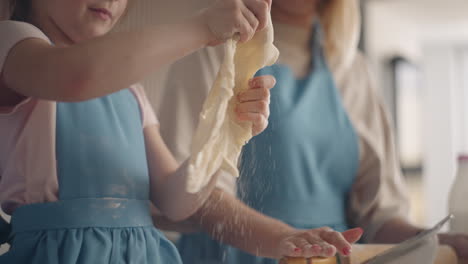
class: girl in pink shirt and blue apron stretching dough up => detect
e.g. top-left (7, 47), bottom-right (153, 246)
top-left (0, 0), bottom-right (269, 264)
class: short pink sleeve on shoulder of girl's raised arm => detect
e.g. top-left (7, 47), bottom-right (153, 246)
top-left (0, 20), bottom-right (50, 72)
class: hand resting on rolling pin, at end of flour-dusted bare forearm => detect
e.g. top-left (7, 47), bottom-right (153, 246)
top-left (279, 227), bottom-right (363, 258)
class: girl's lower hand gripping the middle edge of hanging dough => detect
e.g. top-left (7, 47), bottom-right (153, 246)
top-left (235, 75), bottom-right (276, 136)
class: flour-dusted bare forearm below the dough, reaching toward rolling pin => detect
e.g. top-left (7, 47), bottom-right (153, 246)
top-left (190, 188), bottom-right (296, 258)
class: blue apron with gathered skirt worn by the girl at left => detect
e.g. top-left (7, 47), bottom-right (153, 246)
top-left (0, 89), bottom-right (181, 264)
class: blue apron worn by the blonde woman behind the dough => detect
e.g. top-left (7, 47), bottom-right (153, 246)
top-left (179, 24), bottom-right (359, 264)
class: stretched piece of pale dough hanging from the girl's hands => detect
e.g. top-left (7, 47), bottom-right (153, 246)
top-left (186, 14), bottom-right (279, 193)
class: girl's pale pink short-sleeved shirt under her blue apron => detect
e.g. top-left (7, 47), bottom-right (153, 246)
top-left (0, 21), bottom-right (158, 215)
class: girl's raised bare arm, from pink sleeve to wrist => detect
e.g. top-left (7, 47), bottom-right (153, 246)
top-left (4, 16), bottom-right (210, 101)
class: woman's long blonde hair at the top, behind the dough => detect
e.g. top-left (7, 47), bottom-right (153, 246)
top-left (319, 0), bottom-right (361, 74)
